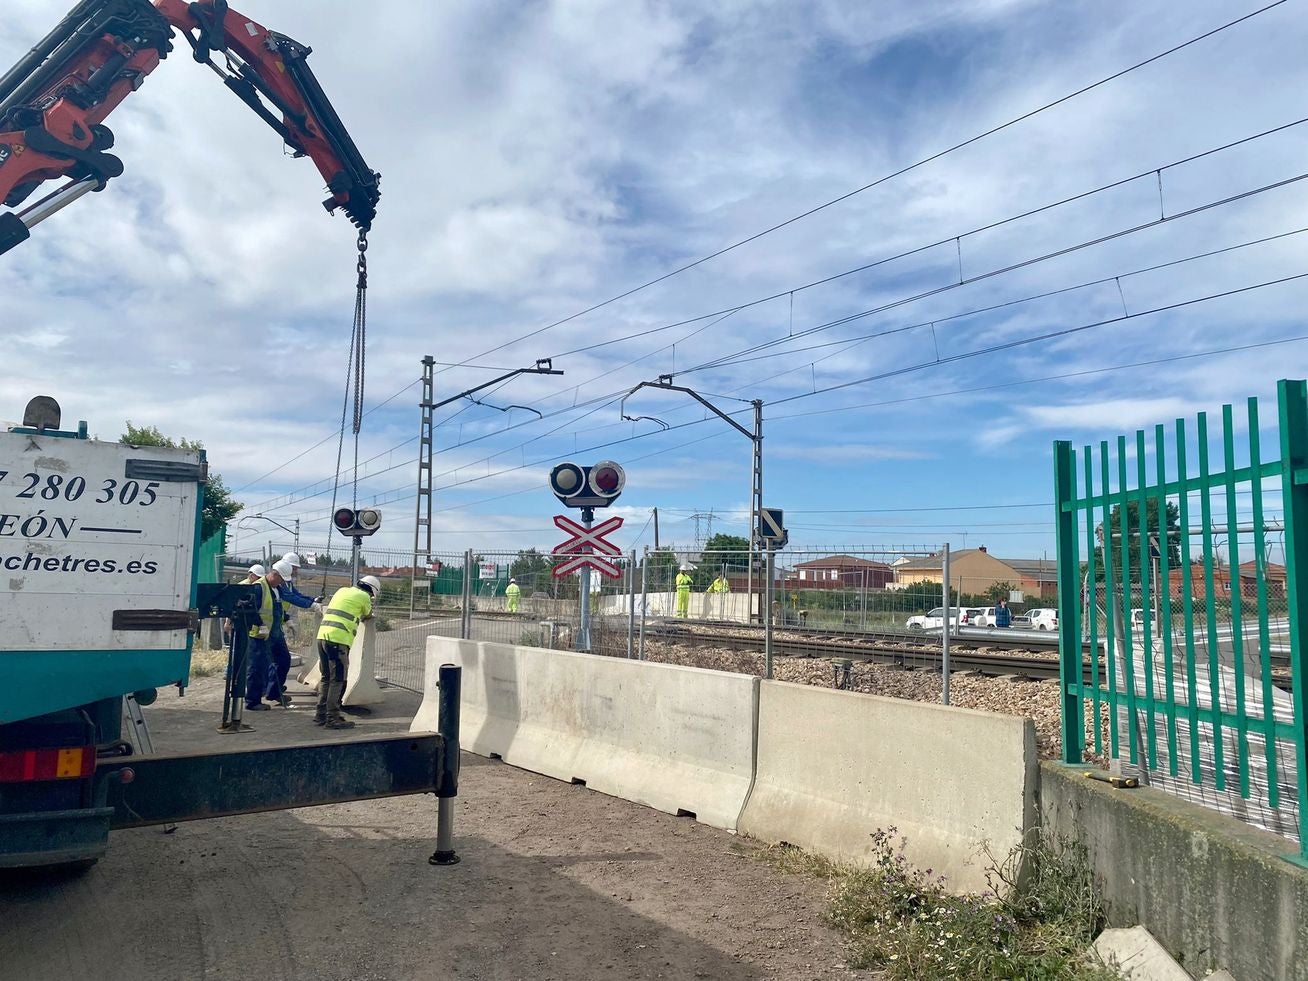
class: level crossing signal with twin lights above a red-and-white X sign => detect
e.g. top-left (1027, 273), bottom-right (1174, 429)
top-left (549, 460), bottom-right (627, 651)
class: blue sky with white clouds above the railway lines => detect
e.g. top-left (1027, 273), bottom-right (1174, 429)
top-left (0, 0), bottom-right (1308, 557)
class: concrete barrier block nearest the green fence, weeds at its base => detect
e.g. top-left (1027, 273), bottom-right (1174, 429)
top-left (739, 681), bottom-right (1039, 892)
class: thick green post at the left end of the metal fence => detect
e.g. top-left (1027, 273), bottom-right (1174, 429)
top-left (1054, 439), bottom-right (1097, 765)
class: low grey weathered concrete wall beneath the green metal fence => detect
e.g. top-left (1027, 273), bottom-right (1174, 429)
top-left (1040, 763), bottom-right (1308, 981)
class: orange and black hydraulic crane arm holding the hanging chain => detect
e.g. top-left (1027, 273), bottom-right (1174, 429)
top-left (0, 0), bottom-right (381, 252)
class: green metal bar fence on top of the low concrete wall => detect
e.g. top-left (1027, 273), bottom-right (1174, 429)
top-left (1054, 381), bottom-right (1308, 865)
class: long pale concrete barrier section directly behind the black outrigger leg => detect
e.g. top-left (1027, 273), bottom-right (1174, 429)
top-left (412, 637), bottom-right (759, 831)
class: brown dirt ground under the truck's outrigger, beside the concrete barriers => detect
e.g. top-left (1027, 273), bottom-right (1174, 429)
top-left (0, 678), bottom-right (869, 981)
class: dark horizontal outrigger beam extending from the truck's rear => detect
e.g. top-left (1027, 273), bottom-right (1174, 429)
top-left (97, 732), bottom-right (445, 829)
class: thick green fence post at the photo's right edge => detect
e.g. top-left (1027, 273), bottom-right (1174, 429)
top-left (1277, 381), bottom-right (1308, 866)
